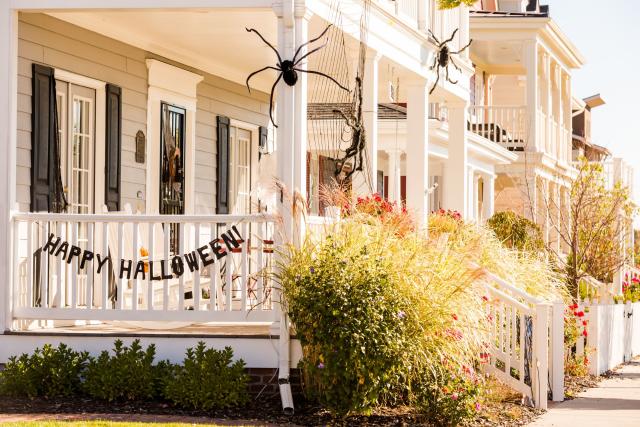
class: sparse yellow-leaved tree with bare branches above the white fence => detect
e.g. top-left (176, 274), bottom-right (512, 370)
top-left (543, 158), bottom-right (635, 295)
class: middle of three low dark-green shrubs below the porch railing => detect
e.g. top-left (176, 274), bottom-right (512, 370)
top-left (84, 340), bottom-right (158, 402)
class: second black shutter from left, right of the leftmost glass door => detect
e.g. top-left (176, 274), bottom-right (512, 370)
top-left (104, 84), bottom-right (122, 211)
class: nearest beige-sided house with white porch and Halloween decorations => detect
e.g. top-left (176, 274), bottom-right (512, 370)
top-left (0, 0), bottom-right (517, 402)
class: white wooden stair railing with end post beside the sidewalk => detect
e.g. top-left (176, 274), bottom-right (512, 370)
top-left (485, 272), bottom-right (564, 409)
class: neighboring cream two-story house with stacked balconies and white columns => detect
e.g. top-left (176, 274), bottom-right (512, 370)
top-left (470, 1), bottom-right (584, 254)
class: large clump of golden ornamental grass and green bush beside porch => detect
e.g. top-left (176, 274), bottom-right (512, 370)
top-left (277, 190), bottom-right (565, 425)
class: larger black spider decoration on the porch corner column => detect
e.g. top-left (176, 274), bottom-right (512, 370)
top-left (246, 24), bottom-right (349, 128)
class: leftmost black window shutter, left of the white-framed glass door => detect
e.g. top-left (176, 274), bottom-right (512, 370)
top-left (31, 64), bottom-right (56, 212)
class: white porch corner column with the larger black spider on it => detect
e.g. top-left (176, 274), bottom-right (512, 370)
top-left (274, 2), bottom-right (296, 242)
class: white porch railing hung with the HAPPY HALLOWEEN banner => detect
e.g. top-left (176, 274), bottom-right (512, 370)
top-left (12, 213), bottom-right (275, 323)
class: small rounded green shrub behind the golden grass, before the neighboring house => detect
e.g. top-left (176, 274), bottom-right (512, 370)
top-left (487, 211), bottom-right (544, 252)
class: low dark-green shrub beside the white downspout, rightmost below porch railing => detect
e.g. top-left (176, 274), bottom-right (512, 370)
top-left (164, 341), bottom-right (249, 410)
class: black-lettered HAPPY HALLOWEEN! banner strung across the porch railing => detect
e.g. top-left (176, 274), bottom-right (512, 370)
top-left (36, 225), bottom-right (244, 281)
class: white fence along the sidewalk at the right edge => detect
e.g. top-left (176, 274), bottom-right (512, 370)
top-left (577, 301), bottom-right (640, 375)
